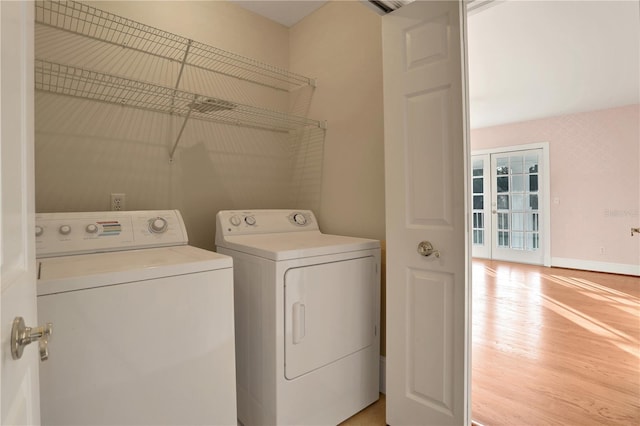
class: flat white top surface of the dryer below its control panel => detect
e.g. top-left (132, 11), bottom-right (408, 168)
top-left (218, 231), bottom-right (380, 261)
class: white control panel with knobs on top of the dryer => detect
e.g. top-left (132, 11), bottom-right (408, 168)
top-left (216, 210), bottom-right (319, 235)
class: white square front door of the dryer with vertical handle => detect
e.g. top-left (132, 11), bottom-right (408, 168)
top-left (285, 257), bottom-right (377, 379)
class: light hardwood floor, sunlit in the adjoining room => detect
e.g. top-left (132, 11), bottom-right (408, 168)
top-left (344, 259), bottom-right (640, 426)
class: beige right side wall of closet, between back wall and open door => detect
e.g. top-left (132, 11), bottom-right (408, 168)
top-left (289, 1), bottom-right (385, 239)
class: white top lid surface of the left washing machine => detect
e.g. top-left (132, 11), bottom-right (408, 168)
top-left (37, 246), bottom-right (233, 296)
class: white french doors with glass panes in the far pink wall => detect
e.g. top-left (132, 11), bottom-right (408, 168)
top-left (471, 147), bottom-right (549, 265)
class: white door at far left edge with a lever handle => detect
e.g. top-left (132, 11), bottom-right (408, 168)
top-left (0, 1), bottom-right (40, 425)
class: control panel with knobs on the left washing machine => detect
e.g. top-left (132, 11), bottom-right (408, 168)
top-left (35, 210), bottom-right (188, 258)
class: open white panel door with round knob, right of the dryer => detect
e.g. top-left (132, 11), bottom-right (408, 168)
top-left (382, 1), bottom-right (470, 426)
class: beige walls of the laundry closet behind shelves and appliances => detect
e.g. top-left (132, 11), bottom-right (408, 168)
top-left (36, 1), bottom-right (384, 249)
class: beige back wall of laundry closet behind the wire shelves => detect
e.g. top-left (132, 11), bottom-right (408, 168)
top-left (35, 1), bottom-right (323, 249)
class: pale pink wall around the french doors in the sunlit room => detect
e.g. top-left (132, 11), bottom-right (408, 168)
top-left (471, 104), bottom-right (640, 273)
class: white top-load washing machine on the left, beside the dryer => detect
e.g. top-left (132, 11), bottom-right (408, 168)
top-left (36, 210), bottom-right (237, 425)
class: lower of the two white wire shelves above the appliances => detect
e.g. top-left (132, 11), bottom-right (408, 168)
top-left (35, 59), bottom-right (323, 134)
